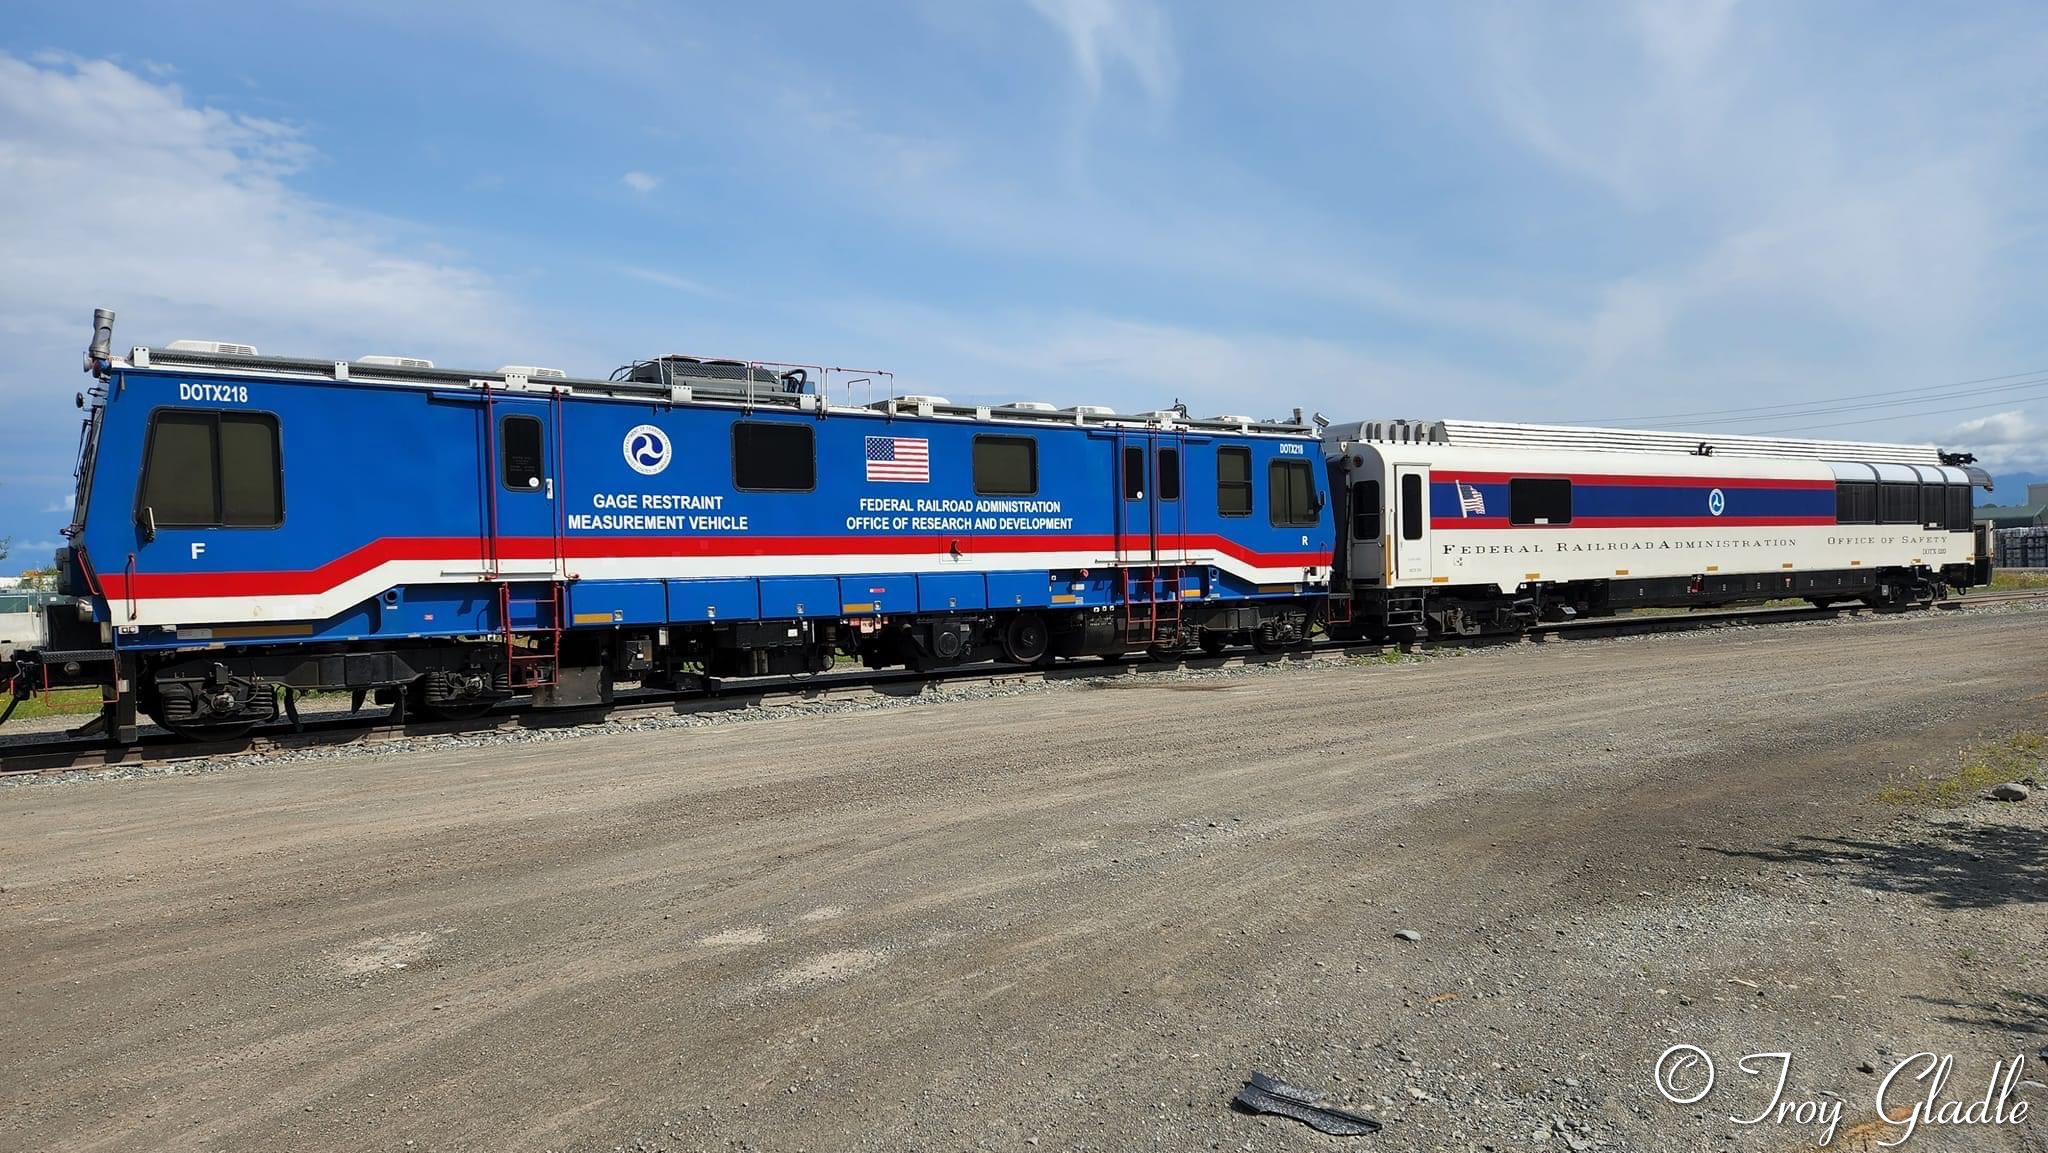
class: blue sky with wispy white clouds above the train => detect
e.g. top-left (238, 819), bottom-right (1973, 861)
top-left (0, 0), bottom-right (2048, 559)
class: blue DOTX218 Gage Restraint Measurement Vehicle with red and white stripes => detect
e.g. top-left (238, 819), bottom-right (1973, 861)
top-left (36, 311), bottom-right (1335, 733)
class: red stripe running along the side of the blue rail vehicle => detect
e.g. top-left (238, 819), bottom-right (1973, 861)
top-left (102, 532), bottom-right (1331, 600)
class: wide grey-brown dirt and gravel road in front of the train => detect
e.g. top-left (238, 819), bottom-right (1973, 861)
top-left (0, 610), bottom-right (2048, 1151)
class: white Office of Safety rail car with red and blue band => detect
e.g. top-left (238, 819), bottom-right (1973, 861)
top-left (1323, 420), bottom-right (1989, 635)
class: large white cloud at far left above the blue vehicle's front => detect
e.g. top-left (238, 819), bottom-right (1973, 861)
top-left (0, 53), bottom-right (522, 360)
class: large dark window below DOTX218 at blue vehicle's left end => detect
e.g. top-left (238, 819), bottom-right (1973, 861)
top-left (137, 412), bottom-right (285, 528)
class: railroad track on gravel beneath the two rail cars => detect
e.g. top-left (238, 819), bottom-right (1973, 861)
top-left (0, 590), bottom-right (2048, 776)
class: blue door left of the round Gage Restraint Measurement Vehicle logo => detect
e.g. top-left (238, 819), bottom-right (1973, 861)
top-left (485, 397), bottom-right (561, 580)
